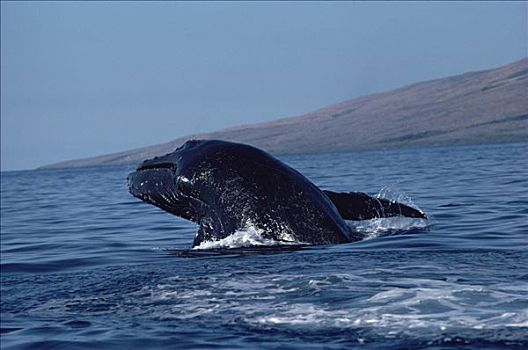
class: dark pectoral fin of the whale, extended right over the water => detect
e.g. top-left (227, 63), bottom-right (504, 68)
top-left (323, 191), bottom-right (427, 220)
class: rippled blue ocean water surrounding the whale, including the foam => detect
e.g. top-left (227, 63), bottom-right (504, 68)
top-left (1, 143), bottom-right (528, 349)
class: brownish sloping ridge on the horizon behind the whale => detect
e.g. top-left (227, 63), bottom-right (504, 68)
top-left (42, 58), bottom-right (528, 168)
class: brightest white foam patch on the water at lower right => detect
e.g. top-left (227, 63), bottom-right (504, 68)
top-left (251, 281), bottom-right (528, 335)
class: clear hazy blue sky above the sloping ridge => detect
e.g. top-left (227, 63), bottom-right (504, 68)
top-left (1, 1), bottom-right (528, 171)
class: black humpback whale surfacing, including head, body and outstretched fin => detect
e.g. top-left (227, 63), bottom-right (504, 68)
top-left (128, 140), bottom-right (426, 247)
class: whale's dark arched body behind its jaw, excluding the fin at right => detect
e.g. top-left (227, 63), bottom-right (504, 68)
top-left (179, 141), bottom-right (350, 245)
